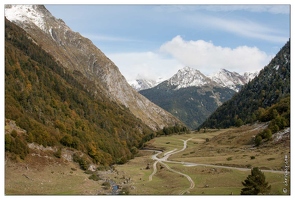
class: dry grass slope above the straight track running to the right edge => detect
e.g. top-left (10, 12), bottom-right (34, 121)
top-left (170, 125), bottom-right (290, 170)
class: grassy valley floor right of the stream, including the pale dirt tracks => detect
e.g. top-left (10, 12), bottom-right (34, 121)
top-left (105, 124), bottom-right (290, 195)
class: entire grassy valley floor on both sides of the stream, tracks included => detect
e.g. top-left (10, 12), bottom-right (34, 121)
top-left (5, 124), bottom-right (290, 195)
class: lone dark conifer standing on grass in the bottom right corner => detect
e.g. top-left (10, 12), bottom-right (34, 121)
top-left (241, 167), bottom-right (271, 195)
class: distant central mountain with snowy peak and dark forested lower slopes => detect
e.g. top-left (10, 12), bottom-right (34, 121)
top-left (139, 67), bottom-right (236, 129)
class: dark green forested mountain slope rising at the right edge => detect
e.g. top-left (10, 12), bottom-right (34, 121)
top-left (200, 41), bottom-right (290, 128)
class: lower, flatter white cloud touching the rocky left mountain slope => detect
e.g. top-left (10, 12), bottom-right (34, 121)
top-left (107, 52), bottom-right (184, 81)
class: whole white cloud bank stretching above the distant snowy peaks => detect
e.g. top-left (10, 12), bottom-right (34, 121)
top-left (107, 36), bottom-right (272, 81)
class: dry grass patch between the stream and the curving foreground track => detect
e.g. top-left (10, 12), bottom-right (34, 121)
top-left (111, 152), bottom-right (189, 195)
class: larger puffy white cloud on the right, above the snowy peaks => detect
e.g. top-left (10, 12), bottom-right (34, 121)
top-left (160, 36), bottom-right (271, 75)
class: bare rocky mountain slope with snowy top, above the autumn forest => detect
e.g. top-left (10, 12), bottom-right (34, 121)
top-left (5, 5), bottom-right (181, 130)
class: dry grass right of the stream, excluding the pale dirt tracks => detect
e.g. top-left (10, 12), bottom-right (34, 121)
top-left (113, 122), bottom-right (290, 195)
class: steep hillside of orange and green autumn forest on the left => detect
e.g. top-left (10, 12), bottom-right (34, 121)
top-left (5, 19), bottom-right (152, 165)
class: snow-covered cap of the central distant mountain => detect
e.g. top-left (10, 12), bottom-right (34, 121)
top-left (168, 67), bottom-right (212, 89)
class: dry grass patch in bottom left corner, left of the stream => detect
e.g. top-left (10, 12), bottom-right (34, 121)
top-left (5, 152), bottom-right (108, 195)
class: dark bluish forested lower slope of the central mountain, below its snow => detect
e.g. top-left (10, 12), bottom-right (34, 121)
top-left (140, 81), bottom-right (235, 129)
